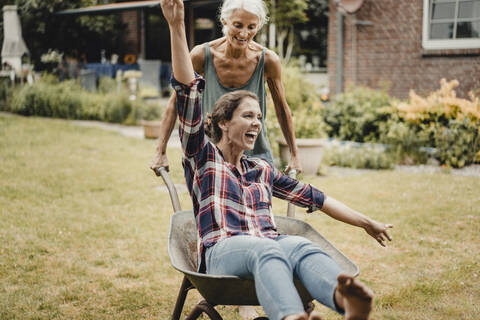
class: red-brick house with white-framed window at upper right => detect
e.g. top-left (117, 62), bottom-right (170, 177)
top-left (327, 0), bottom-right (480, 98)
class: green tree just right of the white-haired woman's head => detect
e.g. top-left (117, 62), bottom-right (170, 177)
top-left (267, 0), bottom-right (308, 62)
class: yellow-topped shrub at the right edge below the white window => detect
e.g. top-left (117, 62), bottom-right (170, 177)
top-left (395, 79), bottom-right (480, 167)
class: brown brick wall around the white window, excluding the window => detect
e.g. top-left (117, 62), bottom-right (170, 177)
top-left (327, 0), bottom-right (480, 98)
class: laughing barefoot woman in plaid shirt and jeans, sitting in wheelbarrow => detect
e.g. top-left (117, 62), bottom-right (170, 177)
top-left (161, 0), bottom-right (392, 320)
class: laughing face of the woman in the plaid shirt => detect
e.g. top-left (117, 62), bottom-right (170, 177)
top-left (221, 97), bottom-right (262, 151)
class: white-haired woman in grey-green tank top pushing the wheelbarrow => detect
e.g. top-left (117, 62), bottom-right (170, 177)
top-left (150, 0), bottom-right (301, 172)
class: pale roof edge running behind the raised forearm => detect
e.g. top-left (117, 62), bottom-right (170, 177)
top-left (56, 0), bottom-right (220, 15)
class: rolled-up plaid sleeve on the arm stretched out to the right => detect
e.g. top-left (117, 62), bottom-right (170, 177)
top-left (273, 168), bottom-right (325, 212)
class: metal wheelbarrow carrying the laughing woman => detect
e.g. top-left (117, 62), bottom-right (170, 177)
top-left (158, 168), bottom-right (359, 320)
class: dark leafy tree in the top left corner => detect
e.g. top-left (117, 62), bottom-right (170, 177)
top-left (0, 0), bottom-right (124, 65)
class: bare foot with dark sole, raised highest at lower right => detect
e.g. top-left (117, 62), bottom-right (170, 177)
top-left (337, 274), bottom-right (373, 320)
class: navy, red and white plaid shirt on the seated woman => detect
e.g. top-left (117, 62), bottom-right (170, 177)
top-left (172, 75), bottom-right (324, 272)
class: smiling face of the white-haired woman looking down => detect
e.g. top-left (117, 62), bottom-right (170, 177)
top-left (222, 9), bottom-right (259, 48)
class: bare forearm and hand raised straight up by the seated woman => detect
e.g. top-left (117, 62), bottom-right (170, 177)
top-left (160, 0), bottom-right (195, 84)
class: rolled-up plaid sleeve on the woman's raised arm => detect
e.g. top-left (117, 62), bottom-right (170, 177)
top-left (171, 74), bottom-right (206, 157)
